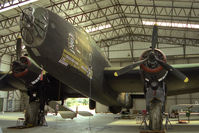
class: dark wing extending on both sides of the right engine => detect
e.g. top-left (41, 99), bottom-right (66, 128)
top-left (104, 64), bottom-right (199, 95)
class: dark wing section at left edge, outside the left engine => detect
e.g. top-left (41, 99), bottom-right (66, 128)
top-left (0, 72), bottom-right (27, 91)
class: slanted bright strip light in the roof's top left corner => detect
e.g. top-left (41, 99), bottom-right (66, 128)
top-left (0, 0), bottom-right (38, 13)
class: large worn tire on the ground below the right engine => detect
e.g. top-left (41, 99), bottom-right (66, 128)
top-left (149, 99), bottom-right (162, 130)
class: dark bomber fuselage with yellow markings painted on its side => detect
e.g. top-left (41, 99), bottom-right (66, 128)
top-left (22, 8), bottom-right (120, 106)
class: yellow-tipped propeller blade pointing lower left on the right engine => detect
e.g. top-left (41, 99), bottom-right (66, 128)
top-left (114, 58), bottom-right (148, 77)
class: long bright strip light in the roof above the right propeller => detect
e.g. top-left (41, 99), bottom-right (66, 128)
top-left (142, 21), bottom-right (199, 29)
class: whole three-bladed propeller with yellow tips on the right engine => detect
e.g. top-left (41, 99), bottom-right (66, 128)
top-left (114, 25), bottom-right (189, 83)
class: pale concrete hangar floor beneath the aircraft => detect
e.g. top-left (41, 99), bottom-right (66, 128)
top-left (0, 113), bottom-right (199, 133)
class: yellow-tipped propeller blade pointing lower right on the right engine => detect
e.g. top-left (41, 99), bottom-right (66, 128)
top-left (156, 58), bottom-right (189, 83)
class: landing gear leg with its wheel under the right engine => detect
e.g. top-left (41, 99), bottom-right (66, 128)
top-left (145, 81), bottom-right (167, 130)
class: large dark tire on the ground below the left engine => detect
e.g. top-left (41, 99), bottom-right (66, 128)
top-left (24, 102), bottom-right (40, 126)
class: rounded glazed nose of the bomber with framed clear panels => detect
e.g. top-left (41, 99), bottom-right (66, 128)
top-left (20, 7), bottom-right (48, 47)
